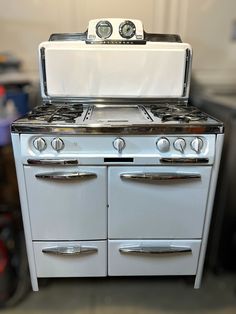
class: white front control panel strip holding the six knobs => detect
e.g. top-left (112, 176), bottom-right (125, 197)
top-left (21, 134), bottom-right (216, 164)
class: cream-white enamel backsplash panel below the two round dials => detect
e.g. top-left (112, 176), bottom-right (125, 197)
top-left (40, 42), bottom-right (191, 97)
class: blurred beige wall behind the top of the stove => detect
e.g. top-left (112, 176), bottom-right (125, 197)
top-left (0, 0), bottom-right (236, 81)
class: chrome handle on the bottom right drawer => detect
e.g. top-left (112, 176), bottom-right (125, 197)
top-left (119, 245), bottom-right (192, 255)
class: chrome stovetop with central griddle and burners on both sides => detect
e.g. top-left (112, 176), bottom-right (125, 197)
top-left (12, 103), bottom-right (222, 133)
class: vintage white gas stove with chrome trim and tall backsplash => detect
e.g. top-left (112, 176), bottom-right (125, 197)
top-left (12, 19), bottom-right (223, 291)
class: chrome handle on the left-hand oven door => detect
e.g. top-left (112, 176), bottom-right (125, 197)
top-left (35, 172), bottom-right (97, 180)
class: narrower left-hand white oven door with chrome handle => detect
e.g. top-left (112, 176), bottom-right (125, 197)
top-left (24, 166), bottom-right (107, 241)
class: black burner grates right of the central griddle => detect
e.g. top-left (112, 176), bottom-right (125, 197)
top-left (151, 104), bottom-right (208, 123)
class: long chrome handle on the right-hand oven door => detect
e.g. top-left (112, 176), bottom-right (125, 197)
top-left (120, 172), bottom-right (201, 181)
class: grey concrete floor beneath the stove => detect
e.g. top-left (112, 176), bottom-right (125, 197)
top-left (1, 274), bottom-right (236, 314)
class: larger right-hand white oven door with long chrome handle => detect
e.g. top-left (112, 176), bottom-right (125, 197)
top-left (108, 166), bottom-right (211, 239)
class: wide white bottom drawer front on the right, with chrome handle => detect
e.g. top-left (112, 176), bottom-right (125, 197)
top-left (108, 240), bottom-right (201, 276)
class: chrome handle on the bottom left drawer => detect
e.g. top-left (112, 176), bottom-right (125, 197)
top-left (42, 246), bottom-right (98, 255)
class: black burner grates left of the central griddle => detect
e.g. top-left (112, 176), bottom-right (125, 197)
top-left (28, 104), bottom-right (83, 123)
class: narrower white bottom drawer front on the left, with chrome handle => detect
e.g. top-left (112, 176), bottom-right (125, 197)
top-left (33, 241), bottom-right (107, 277)
